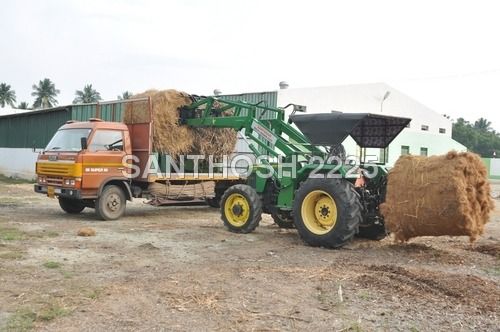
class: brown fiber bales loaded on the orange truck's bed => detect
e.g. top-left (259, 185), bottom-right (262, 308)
top-left (123, 90), bottom-right (237, 157)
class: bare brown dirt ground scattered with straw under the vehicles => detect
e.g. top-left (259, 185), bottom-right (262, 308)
top-left (0, 182), bottom-right (500, 331)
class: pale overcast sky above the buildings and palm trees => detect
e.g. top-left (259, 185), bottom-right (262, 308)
top-left (0, 0), bottom-right (500, 131)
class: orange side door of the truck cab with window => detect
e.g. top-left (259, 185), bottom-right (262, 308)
top-left (82, 129), bottom-right (127, 194)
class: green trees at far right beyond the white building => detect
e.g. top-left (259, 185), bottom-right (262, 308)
top-left (452, 118), bottom-right (500, 157)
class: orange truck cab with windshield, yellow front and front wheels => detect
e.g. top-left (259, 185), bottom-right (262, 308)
top-left (35, 119), bottom-right (132, 220)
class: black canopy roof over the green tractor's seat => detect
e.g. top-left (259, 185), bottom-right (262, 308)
top-left (290, 112), bottom-right (411, 148)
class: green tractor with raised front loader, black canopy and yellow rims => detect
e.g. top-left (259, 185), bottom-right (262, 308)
top-left (180, 96), bottom-right (411, 248)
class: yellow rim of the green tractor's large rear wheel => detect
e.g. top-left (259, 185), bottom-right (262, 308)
top-left (301, 190), bottom-right (337, 235)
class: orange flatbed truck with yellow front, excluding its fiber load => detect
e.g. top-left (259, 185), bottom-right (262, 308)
top-left (34, 98), bottom-right (238, 220)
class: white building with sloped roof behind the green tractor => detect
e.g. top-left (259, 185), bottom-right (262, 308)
top-left (229, 83), bottom-right (467, 165)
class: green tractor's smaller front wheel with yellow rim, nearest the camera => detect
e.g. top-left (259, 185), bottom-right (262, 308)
top-left (220, 184), bottom-right (262, 233)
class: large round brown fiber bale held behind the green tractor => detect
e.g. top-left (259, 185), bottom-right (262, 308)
top-left (380, 151), bottom-right (494, 242)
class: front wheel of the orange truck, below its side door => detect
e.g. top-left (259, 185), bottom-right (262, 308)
top-left (95, 185), bottom-right (127, 220)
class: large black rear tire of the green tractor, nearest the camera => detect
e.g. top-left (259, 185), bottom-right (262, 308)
top-left (293, 179), bottom-right (362, 248)
